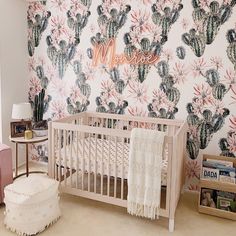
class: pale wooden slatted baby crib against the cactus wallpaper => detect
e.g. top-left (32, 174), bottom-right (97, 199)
top-left (48, 112), bottom-right (187, 231)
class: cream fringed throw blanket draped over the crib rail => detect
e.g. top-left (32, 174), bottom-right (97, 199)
top-left (127, 128), bottom-right (165, 219)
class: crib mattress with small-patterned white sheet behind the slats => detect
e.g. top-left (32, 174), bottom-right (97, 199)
top-left (55, 137), bottom-right (168, 186)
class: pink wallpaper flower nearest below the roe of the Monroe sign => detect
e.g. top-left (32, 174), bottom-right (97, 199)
top-left (129, 81), bottom-right (148, 104)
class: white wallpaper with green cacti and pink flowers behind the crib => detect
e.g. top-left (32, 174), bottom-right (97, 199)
top-left (27, 0), bottom-right (236, 190)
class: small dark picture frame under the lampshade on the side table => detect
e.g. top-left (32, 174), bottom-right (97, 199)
top-left (11, 120), bottom-right (32, 138)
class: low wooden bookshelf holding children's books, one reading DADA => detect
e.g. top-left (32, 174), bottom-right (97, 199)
top-left (198, 155), bottom-right (236, 220)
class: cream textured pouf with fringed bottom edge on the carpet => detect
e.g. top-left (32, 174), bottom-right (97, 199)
top-left (4, 175), bottom-right (61, 235)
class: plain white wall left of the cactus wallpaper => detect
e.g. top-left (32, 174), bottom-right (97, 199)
top-left (0, 0), bottom-right (28, 166)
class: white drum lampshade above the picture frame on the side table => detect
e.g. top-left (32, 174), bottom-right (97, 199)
top-left (11, 102), bottom-right (32, 120)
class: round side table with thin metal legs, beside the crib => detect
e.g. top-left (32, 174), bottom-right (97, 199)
top-left (9, 136), bottom-right (48, 179)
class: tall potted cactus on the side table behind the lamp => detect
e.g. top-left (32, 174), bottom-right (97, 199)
top-left (31, 89), bottom-right (48, 137)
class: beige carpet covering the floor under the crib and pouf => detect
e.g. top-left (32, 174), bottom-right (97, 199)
top-left (0, 163), bottom-right (236, 236)
